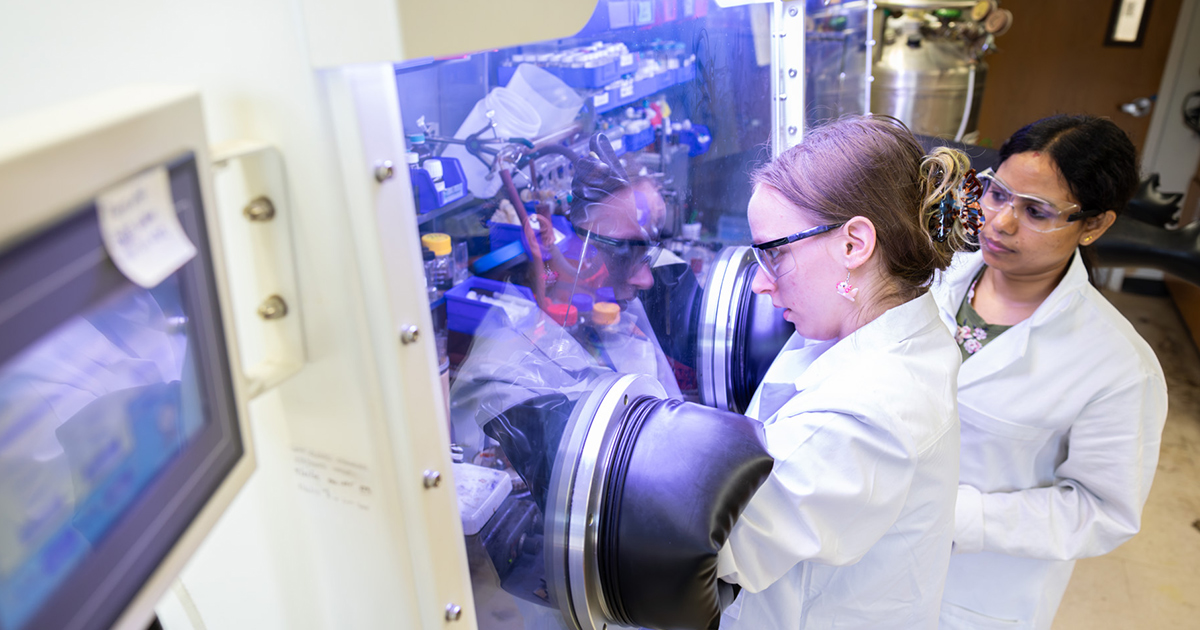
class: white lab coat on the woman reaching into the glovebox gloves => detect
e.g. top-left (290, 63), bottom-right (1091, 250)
top-left (718, 289), bottom-right (960, 630)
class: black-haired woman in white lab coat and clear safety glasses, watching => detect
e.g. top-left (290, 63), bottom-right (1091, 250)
top-left (932, 115), bottom-right (1166, 629)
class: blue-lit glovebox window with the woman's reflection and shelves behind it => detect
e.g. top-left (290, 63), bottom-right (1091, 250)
top-left (396, 0), bottom-right (772, 629)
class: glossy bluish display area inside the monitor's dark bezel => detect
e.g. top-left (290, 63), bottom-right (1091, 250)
top-left (0, 278), bottom-right (204, 628)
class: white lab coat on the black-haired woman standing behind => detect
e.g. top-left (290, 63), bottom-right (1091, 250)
top-left (932, 253), bottom-right (1166, 629)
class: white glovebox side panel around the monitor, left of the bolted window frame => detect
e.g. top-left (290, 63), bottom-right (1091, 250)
top-left (0, 0), bottom-right (429, 630)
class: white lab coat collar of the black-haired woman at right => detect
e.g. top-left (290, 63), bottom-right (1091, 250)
top-left (931, 250), bottom-right (1087, 388)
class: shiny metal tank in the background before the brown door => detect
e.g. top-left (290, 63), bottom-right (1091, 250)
top-left (871, 0), bottom-right (1013, 143)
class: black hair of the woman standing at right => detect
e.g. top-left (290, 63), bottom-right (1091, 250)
top-left (1000, 114), bottom-right (1139, 216)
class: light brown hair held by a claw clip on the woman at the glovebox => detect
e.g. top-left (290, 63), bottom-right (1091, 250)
top-left (751, 115), bottom-right (971, 301)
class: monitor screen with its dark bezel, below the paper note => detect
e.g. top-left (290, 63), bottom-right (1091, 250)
top-left (0, 154), bottom-right (242, 630)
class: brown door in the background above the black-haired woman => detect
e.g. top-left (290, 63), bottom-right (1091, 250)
top-left (979, 0), bottom-right (1181, 152)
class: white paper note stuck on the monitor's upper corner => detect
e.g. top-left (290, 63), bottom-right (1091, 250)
top-left (96, 167), bottom-right (196, 289)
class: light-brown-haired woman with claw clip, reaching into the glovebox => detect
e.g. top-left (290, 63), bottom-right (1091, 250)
top-left (718, 116), bottom-right (979, 630)
